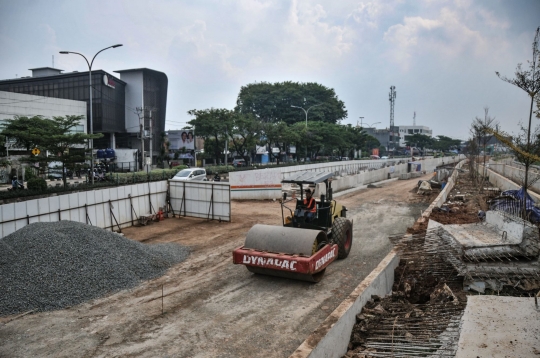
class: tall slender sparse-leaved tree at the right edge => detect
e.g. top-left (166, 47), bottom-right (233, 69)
top-left (495, 27), bottom-right (540, 190)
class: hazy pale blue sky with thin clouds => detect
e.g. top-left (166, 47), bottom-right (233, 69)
top-left (0, 0), bottom-right (540, 140)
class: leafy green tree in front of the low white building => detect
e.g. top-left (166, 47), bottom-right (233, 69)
top-left (2, 115), bottom-right (103, 185)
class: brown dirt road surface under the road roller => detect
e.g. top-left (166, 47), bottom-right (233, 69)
top-left (0, 175), bottom-right (433, 357)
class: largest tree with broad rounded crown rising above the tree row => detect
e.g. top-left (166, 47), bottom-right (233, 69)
top-left (235, 82), bottom-right (347, 125)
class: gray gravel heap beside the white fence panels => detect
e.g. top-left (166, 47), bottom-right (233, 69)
top-left (0, 221), bottom-right (189, 316)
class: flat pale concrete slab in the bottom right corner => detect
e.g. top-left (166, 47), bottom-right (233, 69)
top-left (456, 296), bottom-right (540, 358)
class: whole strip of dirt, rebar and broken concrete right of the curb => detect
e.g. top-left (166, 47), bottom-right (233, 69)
top-left (345, 164), bottom-right (540, 358)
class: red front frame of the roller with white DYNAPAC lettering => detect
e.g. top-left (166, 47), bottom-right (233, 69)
top-left (233, 244), bottom-right (338, 275)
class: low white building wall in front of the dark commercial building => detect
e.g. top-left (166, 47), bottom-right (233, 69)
top-left (0, 91), bottom-right (87, 133)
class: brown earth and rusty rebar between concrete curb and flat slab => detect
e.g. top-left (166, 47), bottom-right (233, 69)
top-left (345, 233), bottom-right (466, 358)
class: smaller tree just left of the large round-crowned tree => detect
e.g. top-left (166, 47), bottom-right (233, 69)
top-left (188, 108), bottom-right (234, 164)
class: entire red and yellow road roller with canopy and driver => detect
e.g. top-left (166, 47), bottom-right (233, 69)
top-left (233, 171), bottom-right (353, 282)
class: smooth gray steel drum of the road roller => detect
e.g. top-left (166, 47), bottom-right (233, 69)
top-left (244, 224), bottom-right (328, 257)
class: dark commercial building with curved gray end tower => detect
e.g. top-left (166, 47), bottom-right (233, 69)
top-left (0, 67), bottom-right (168, 163)
